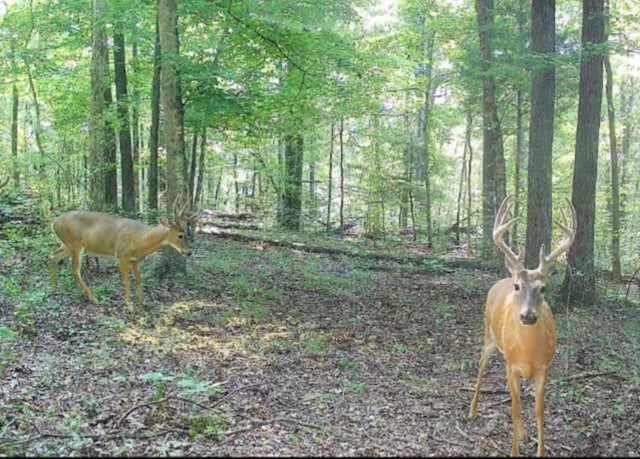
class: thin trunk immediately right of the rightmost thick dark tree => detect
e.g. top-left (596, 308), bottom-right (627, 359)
top-left (604, 2), bottom-right (622, 279)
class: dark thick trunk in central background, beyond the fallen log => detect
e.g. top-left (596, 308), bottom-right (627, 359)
top-left (282, 134), bottom-right (303, 231)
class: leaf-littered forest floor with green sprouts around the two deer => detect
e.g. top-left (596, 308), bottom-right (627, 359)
top-left (0, 226), bottom-right (640, 456)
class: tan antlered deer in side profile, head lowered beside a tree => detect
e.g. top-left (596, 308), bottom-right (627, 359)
top-left (49, 197), bottom-right (198, 305)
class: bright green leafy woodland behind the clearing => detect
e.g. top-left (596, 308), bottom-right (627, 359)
top-left (0, 0), bottom-right (640, 294)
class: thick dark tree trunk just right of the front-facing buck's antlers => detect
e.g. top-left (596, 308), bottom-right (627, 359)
top-left (562, 0), bottom-right (605, 305)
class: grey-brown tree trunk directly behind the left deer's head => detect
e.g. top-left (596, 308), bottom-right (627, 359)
top-left (158, 0), bottom-right (188, 273)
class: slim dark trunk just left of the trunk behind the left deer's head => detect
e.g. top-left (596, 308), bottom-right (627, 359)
top-left (147, 13), bottom-right (162, 216)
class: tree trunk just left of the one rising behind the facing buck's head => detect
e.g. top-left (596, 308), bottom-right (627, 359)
top-left (476, 0), bottom-right (506, 258)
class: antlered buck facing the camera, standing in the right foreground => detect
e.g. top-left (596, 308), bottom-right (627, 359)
top-left (469, 195), bottom-right (576, 456)
